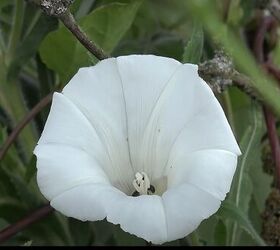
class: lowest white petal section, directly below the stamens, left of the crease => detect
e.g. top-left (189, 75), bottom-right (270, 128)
top-left (107, 195), bottom-right (167, 244)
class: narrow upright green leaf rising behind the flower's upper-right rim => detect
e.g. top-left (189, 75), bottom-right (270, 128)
top-left (183, 23), bottom-right (204, 64)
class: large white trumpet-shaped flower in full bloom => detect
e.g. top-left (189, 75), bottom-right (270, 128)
top-left (35, 55), bottom-right (240, 244)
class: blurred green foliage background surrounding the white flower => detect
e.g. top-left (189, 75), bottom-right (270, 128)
top-left (0, 0), bottom-right (280, 246)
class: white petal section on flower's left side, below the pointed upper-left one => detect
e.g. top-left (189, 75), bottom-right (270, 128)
top-left (35, 143), bottom-right (110, 200)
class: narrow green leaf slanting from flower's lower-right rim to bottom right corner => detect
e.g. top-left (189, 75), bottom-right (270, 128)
top-left (217, 202), bottom-right (266, 246)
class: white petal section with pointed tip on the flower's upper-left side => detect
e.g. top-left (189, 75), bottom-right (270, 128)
top-left (38, 93), bottom-right (105, 159)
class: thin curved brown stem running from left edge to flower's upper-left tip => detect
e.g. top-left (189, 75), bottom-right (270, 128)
top-left (0, 93), bottom-right (53, 161)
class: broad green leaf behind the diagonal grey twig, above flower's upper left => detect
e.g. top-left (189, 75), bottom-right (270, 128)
top-left (40, 0), bottom-right (142, 83)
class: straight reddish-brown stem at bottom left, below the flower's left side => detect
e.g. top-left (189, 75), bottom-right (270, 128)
top-left (0, 204), bottom-right (54, 243)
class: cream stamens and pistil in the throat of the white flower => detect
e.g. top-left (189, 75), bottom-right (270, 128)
top-left (132, 172), bottom-right (155, 196)
